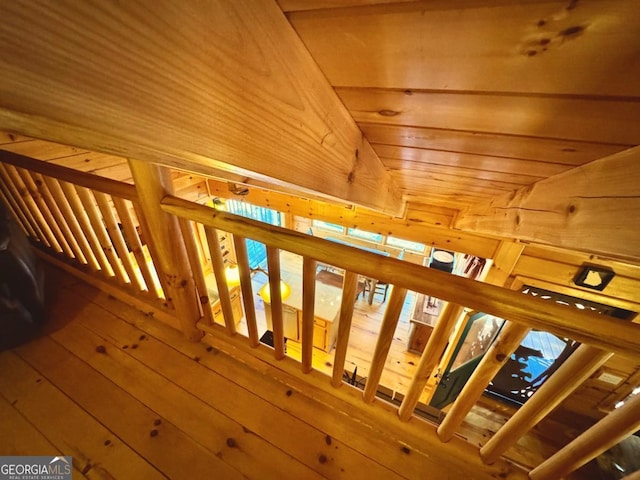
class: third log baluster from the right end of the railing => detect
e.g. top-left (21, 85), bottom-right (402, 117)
top-left (437, 322), bottom-right (530, 442)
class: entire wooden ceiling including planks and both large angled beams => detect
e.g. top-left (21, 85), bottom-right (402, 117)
top-left (0, 0), bottom-right (640, 259)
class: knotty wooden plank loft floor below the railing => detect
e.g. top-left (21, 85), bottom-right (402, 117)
top-left (0, 271), bottom-right (526, 480)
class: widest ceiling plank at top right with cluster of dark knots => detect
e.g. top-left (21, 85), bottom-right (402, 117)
top-left (289, 0), bottom-right (640, 97)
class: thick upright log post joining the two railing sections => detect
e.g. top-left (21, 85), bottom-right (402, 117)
top-left (129, 159), bottom-right (203, 341)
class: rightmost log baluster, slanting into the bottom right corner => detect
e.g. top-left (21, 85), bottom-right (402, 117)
top-left (529, 395), bottom-right (640, 480)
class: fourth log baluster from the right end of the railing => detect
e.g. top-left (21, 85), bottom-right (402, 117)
top-left (398, 302), bottom-right (464, 422)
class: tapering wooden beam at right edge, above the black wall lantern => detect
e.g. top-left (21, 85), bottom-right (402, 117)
top-left (455, 147), bottom-right (640, 262)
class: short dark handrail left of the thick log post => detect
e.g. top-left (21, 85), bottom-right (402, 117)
top-left (0, 150), bottom-right (138, 201)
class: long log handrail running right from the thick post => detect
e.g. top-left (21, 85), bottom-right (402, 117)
top-left (161, 196), bottom-right (640, 358)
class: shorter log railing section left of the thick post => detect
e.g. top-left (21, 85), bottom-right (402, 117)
top-left (0, 151), bottom-right (168, 316)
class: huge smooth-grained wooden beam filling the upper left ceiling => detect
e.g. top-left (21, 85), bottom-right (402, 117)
top-left (0, 0), bottom-right (403, 214)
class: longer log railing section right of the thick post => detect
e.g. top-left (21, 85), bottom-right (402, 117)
top-left (161, 196), bottom-right (640, 480)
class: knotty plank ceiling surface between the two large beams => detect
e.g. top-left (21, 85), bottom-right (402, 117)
top-left (279, 0), bottom-right (640, 209)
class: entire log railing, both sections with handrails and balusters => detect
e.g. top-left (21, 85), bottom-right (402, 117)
top-left (0, 152), bottom-right (640, 479)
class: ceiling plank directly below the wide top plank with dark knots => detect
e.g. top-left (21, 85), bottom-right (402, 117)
top-left (336, 88), bottom-right (640, 145)
